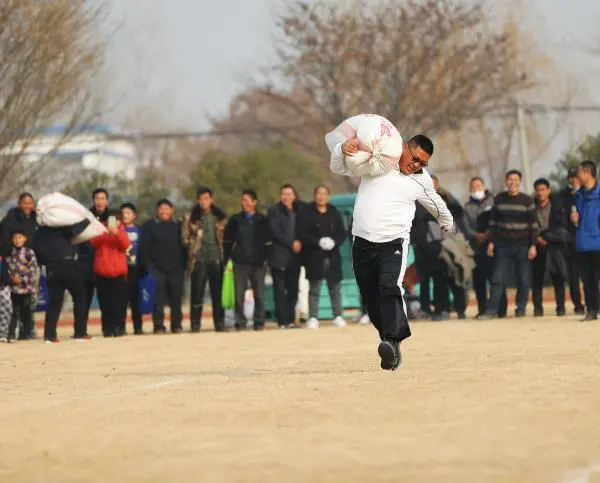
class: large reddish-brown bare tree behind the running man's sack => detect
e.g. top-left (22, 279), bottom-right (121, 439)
top-left (214, 0), bottom-right (533, 179)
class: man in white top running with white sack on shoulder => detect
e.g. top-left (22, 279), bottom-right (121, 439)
top-left (325, 116), bottom-right (454, 370)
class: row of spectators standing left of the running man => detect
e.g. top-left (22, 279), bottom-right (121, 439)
top-left (0, 184), bottom-right (348, 343)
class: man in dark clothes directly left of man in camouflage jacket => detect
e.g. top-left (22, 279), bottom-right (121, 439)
top-left (139, 199), bottom-right (185, 334)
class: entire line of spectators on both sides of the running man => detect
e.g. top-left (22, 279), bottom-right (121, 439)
top-left (0, 161), bottom-right (600, 343)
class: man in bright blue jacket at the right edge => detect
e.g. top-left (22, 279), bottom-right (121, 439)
top-left (571, 161), bottom-right (600, 321)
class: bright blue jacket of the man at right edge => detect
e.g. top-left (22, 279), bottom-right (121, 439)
top-left (575, 183), bottom-right (600, 252)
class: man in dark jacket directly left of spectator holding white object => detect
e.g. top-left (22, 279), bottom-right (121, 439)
top-left (267, 184), bottom-right (303, 329)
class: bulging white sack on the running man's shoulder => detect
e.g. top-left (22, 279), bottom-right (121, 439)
top-left (325, 114), bottom-right (402, 176)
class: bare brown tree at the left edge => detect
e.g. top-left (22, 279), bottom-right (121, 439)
top-left (0, 0), bottom-right (105, 201)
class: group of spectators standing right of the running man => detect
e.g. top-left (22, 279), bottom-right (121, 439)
top-left (411, 161), bottom-right (600, 321)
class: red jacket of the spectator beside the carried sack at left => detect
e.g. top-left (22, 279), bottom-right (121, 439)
top-left (90, 226), bottom-right (131, 278)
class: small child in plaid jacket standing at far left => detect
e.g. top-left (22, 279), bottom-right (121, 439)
top-left (7, 230), bottom-right (39, 340)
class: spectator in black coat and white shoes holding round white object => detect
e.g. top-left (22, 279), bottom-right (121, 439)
top-left (298, 185), bottom-right (347, 329)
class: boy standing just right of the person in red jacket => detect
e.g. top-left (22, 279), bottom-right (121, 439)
top-left (121, 203), bottom-right (144, 335)
